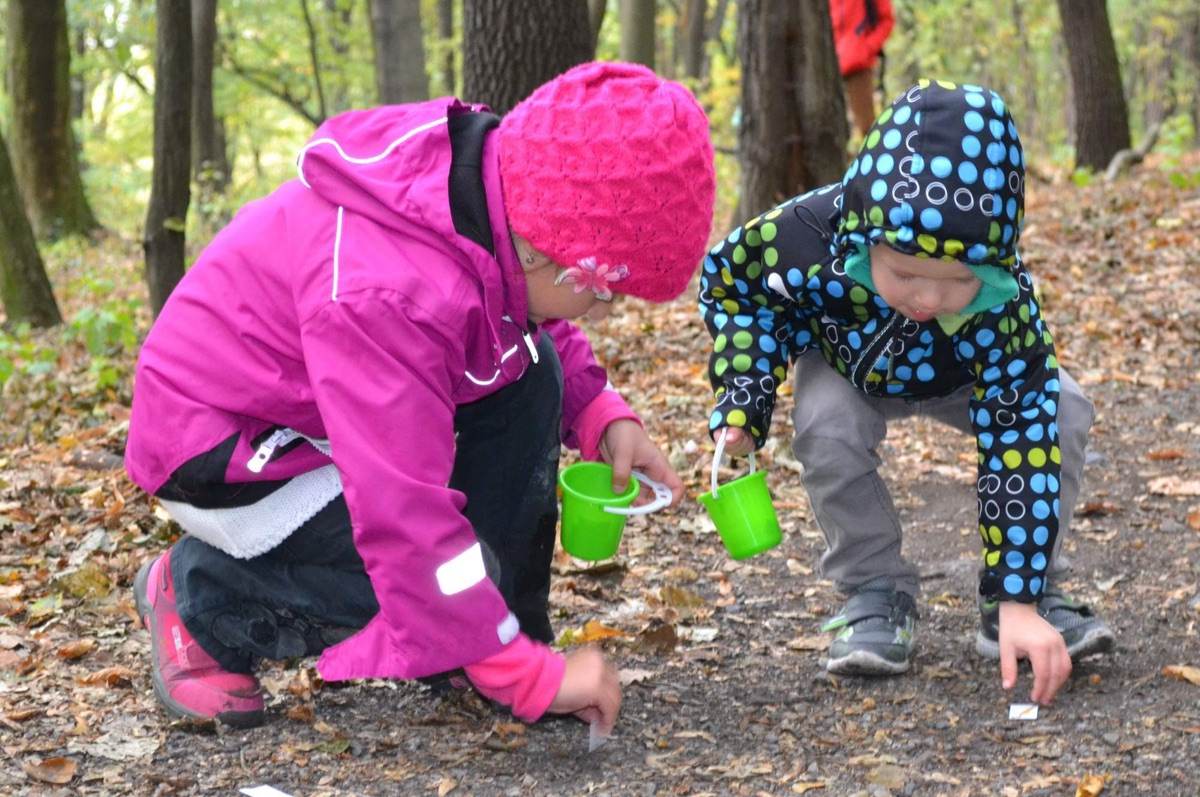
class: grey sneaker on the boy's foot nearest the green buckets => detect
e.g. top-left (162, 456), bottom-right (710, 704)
top-left (821, 579), bottom-right (917, 676)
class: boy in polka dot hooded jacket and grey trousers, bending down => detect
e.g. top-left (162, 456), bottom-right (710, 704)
top-left (700, 80), bottom-right (1114, 703)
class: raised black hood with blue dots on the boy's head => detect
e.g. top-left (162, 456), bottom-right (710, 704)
top-left (834, 80), bottom-right (1025, 271)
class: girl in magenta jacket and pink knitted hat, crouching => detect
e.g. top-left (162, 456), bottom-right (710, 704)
top-left (126, 62), bottom-right (714, 732)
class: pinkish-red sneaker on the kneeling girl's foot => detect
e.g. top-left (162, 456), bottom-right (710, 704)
top-left (133, 551), bottom-right (263, 727)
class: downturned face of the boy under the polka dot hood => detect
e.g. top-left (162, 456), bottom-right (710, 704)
top-left (871, 249), bottom-right (980, 322)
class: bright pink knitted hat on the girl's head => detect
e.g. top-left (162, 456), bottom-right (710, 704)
top-left (497, 61), bottom-right (716, 301)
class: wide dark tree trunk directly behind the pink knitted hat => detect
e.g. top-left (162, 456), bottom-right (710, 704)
top-left (462, 0), bottom-right (593, 114)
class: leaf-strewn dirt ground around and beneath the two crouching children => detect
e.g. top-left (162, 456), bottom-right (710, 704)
top-left (0, 171), bottom-right (1200, 797)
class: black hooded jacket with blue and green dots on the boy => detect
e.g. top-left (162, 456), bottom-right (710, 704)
top-left (700, 82), bottom-right (1061, 603)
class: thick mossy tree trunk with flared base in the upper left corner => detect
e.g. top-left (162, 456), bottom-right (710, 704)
top-left (6, 0), bottom-right (100, 238)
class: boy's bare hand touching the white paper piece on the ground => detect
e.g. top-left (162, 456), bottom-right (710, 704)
top-left (1000, 601), bottom-right (1070, 706)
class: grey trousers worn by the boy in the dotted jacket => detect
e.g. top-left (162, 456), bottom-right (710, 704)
top-left (792, 352), bottom-right (1096, 597)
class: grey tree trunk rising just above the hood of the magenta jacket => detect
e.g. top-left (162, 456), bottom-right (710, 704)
top-left (370, 0), bottom-right (430, 104)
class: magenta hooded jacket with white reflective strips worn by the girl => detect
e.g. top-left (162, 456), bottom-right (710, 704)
top-left (126, 98), bottom-right (634, 691)
